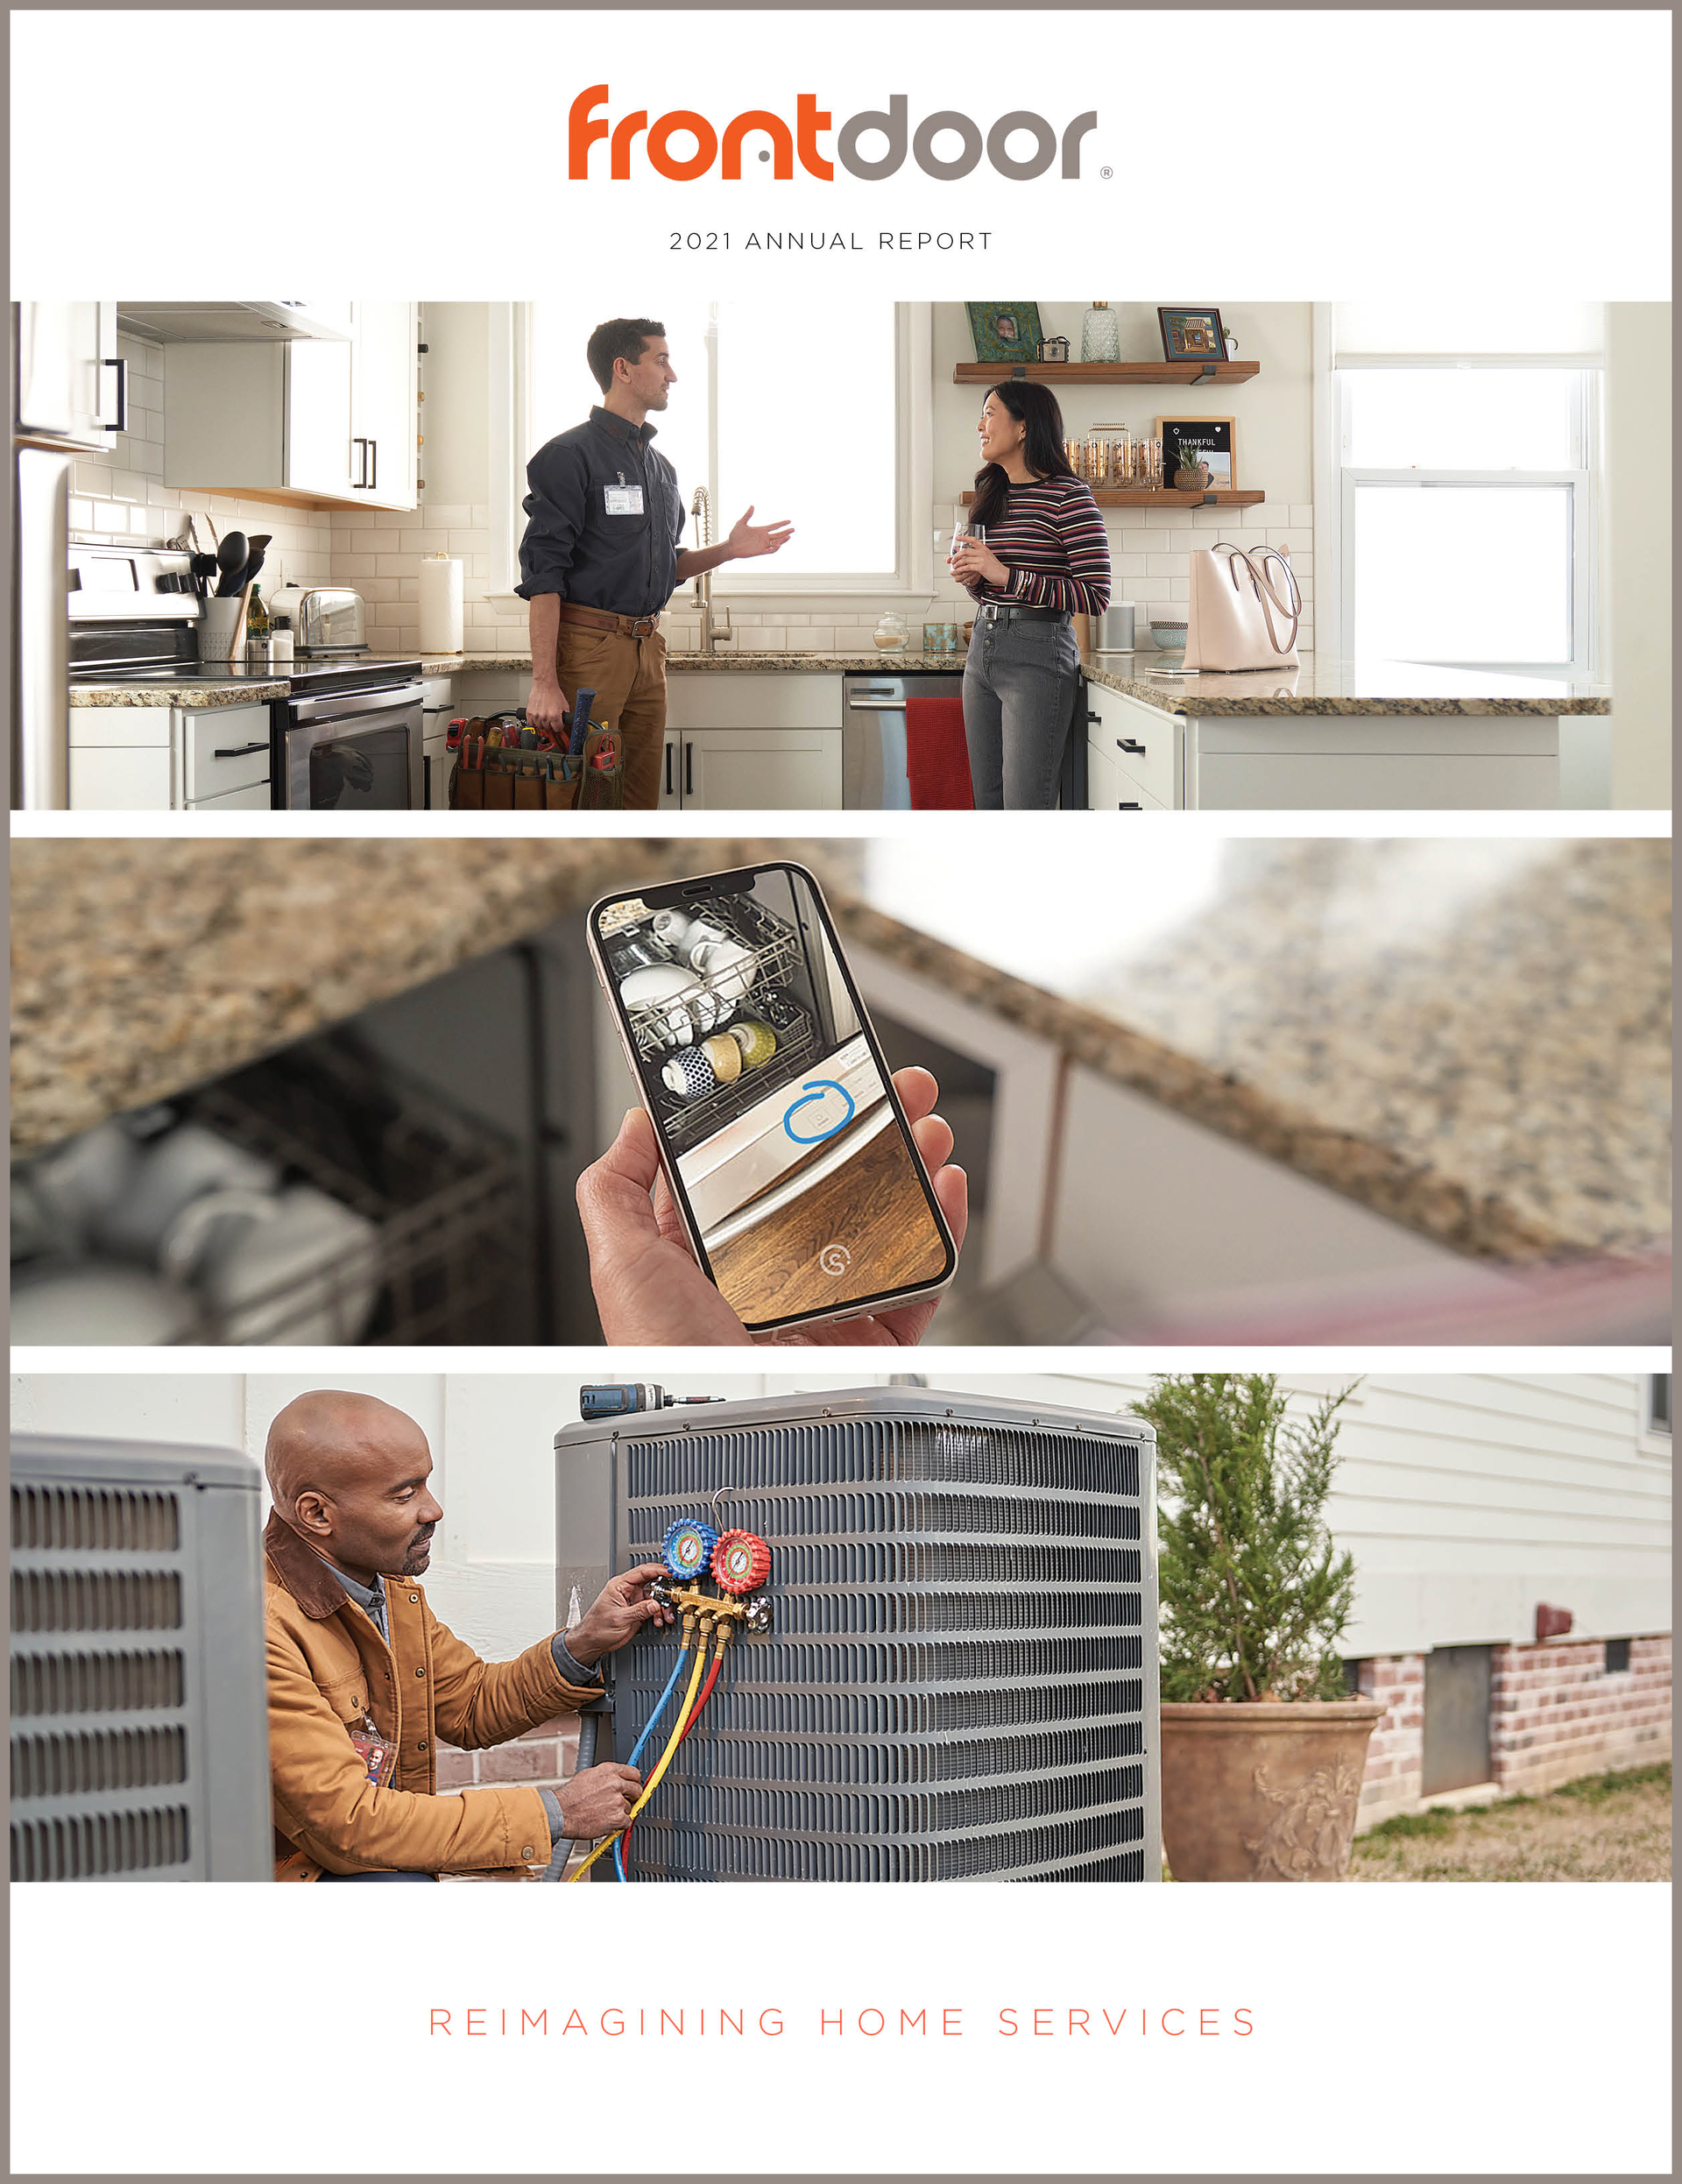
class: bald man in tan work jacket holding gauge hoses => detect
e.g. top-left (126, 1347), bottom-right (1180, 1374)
top-left (262, 1389), bottom-right (671, 1880)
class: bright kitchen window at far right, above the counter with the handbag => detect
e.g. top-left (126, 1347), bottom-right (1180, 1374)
top-left (1335, 358), bottom-right (1601, 675)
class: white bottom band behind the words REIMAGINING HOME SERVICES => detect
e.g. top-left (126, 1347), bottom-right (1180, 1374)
top-left (11, 1884), bottom-right (1669, 2175)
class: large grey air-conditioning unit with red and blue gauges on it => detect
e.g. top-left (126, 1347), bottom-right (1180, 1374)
top-left (555, 1387), bottom-right (1163, 1880)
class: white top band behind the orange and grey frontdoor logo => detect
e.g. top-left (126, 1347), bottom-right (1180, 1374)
top-left (11, 9), bottom-right (1671, 301)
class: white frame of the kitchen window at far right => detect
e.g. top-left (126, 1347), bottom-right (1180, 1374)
top-left (1315, 344), bottom-right (1601, 677)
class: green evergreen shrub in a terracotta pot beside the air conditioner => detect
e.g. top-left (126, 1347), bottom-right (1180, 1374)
top-left (1136, 1372), bottom-right (1382, 1880)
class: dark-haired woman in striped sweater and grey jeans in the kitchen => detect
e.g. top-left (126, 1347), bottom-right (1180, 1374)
top-left (952, 380), bottom-right (1110, 810)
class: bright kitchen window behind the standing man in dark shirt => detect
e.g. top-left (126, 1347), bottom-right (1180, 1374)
top-left (519, 297), bottom-right (930, 597)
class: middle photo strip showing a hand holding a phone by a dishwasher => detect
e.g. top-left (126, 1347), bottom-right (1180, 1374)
top-left (11, 819), bottom-right (1671, 1350)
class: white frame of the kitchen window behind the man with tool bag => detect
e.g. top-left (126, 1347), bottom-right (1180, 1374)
top-left (490, 304), bottom-right (935, 607)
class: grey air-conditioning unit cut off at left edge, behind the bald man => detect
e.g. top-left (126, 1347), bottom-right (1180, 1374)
top-left (11, 1437), bottom-right (273, 1880)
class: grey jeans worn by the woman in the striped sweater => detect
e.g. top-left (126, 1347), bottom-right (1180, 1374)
top-left (964, 614), bottom-right (1081, 812)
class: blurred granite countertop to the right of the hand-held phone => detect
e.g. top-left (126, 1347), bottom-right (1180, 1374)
top-left (852, 828), bottom-right (1671, 1262)
